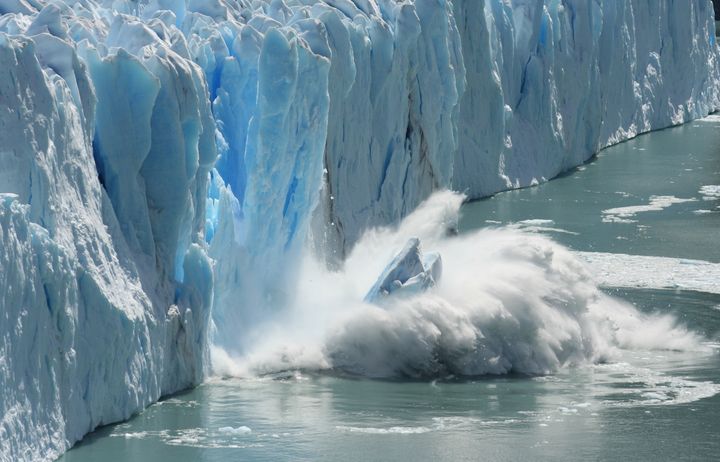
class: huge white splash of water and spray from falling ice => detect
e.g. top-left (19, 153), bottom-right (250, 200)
top-left (212, 191), bottom-right (702, 378)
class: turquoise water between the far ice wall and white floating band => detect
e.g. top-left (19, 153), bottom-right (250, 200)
top-left (460, 117), bottom-right (720, 262)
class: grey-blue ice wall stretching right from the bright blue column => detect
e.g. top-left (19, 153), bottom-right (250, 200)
top-left (316, 0), bottom-right (718, 251)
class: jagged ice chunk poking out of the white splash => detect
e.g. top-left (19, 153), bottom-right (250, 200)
top-left (365, 237), bottom-right (442, 303)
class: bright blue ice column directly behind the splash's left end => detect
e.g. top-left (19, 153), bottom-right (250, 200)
top-left (191, 15), bottom-right (330, 352)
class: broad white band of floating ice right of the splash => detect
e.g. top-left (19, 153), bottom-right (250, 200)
top-left (575, 252), bottom-right (720, 294)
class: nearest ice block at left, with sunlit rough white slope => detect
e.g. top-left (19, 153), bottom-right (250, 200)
top-left (0, 11), bottom-right (215, 460)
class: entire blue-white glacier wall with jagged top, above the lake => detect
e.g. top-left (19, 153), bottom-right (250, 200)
top-left (0, 0), bottom-right (720, 461)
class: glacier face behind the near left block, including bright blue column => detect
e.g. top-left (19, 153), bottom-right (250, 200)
top-left (201, 0), bottom-right (720, 353)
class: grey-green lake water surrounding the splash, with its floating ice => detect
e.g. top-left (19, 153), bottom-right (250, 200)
top-left (61, 117), bottom-right (720, 462)
